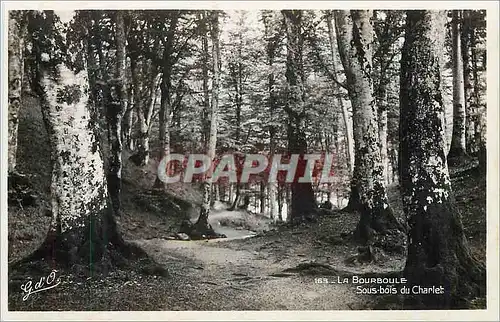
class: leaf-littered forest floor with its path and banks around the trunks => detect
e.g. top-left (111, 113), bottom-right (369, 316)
top-left (8, 97), bottom-right (486, 311)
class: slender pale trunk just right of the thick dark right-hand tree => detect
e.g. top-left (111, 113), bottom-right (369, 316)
top-left (448, 10), bottom-right (467, 159)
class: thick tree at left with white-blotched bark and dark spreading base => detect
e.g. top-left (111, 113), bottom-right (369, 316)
top-left (12, 11), bottom-right (147, 274)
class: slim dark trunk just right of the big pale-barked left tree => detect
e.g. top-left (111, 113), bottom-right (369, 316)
top-left (106, 10), bottom-right (127, 215)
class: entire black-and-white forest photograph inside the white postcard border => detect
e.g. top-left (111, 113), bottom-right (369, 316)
top-left (2, 9), bottom-right (487, 311)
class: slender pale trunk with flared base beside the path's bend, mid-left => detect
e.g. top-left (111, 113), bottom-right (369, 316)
top-left (195, 10), bottom-right (220, 235)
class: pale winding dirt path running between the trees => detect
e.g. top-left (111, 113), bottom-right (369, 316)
top-left (131, 210), bottom-right (374, 310)
